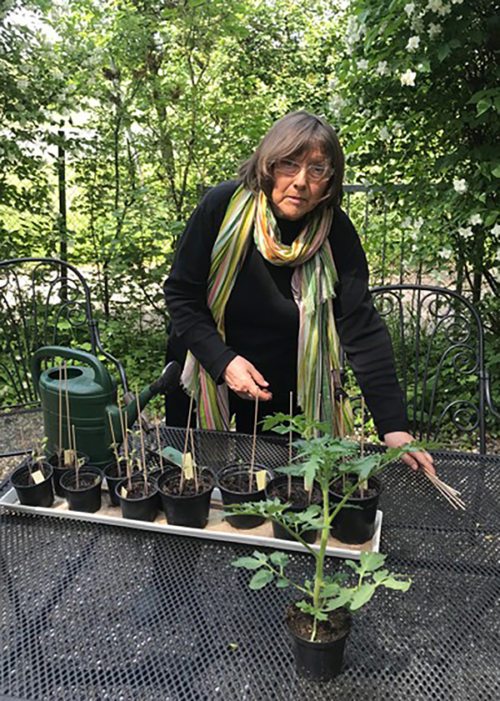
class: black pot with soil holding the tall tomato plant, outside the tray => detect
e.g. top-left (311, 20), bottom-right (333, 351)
top-left (286, 604), bottom-right (352, 681)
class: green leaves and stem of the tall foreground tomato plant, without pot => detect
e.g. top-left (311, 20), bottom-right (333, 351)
top-left (227, 413), bottom-right (410, 640)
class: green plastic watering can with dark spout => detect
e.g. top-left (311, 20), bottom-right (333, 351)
top-left (31, 346), bottom-right (180, 467)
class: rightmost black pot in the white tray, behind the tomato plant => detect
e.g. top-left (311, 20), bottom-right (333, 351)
top-left (329, 475), bottom-right (382, 545)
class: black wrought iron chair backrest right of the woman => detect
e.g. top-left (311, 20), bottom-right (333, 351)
top-left (371, 285), bottom-right (486, 453)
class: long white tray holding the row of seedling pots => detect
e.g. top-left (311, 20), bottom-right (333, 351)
top-left (0, 488), bottom-right (382, 559)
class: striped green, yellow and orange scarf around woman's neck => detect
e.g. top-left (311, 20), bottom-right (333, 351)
top-left (182, 185), bottom-right (352, 435)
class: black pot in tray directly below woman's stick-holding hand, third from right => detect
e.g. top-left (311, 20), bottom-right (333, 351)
top-left (217, 465), bottom-right (274, 528)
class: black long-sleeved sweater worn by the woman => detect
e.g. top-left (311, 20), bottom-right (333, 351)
top-left (164, 181), bottom-right (408, 436)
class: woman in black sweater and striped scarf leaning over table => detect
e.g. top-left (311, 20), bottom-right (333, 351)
top-left (164, 111), bottom-right (433, 471)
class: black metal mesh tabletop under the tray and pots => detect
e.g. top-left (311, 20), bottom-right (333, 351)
top-left (0, 429), bottom-right (500, 701)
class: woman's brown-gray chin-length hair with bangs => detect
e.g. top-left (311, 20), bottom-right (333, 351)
top-left (239, 110), bottom-right (344, 206)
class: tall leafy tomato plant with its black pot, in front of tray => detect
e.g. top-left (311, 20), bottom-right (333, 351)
top-left (230, 414), bottom-right (410, 680)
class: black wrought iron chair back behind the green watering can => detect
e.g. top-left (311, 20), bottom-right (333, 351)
top-left (0, 258), bottom-right (127, 458)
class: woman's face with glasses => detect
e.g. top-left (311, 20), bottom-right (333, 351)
top-left (271, 149), bottom-right (332, 221)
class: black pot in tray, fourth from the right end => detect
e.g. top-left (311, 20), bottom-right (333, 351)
top-left (157, 467), bottom-right (215, 528)
